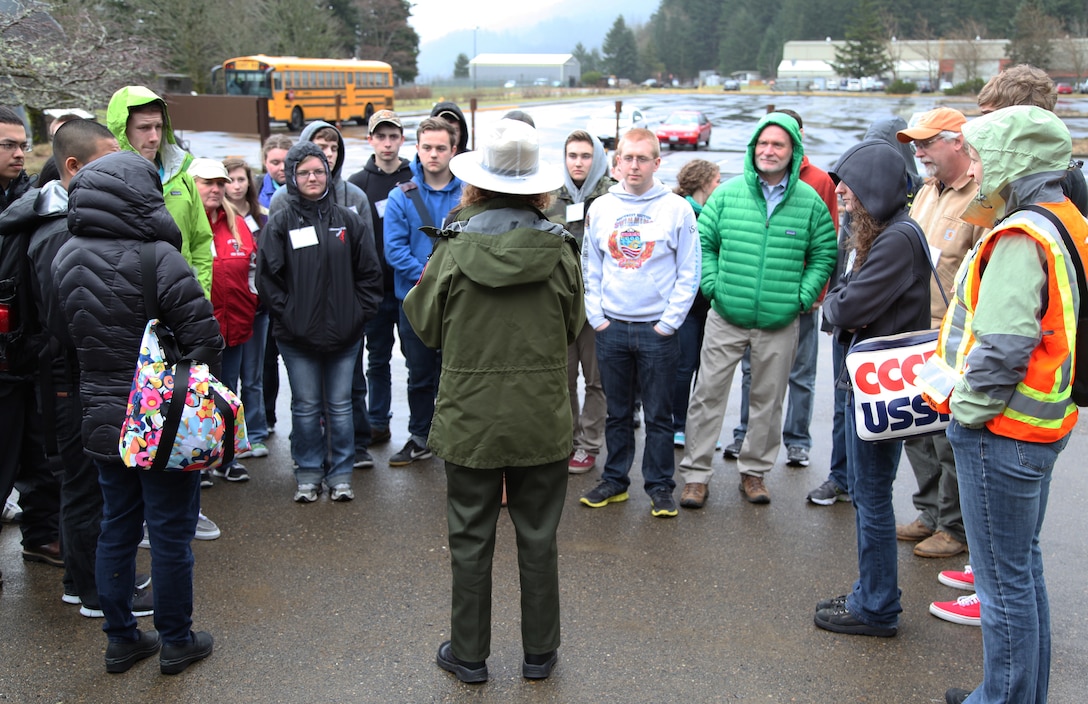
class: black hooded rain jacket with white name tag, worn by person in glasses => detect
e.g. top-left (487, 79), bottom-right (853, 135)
top-left (257, 141), bottom-right (382, 351)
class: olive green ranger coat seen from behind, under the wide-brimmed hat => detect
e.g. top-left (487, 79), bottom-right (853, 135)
top-left (404, 198), bottom-right (585, 469)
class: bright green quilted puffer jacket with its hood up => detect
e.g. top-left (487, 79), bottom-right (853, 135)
top-left (698, 112), bottom-right (836, 330)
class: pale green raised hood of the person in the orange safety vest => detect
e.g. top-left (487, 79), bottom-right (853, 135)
top-left (963, 106), bottom-right (1073, 227)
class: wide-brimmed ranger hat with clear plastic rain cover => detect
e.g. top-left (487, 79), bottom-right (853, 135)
top-left (449, 119), bottom-right (562, 196)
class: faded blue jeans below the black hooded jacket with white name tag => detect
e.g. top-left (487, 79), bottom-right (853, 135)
top-left (279, 339), bottom-right (361, 486)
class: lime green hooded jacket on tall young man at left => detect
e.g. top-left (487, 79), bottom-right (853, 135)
top-left (106, 86), bottom-right (212, 298)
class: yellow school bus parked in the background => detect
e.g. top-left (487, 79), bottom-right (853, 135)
top-left (212, 54), bottom-right (393, 131)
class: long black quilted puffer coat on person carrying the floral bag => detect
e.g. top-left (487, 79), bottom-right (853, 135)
top-left (52, 151), bottom-right (223, 460)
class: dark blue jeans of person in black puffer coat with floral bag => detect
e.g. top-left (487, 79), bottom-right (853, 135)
top-left (95, 460), bottom-right (200, 645)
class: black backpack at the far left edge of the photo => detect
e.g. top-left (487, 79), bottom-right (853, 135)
top-left (0, 232), bottom-right (42, 376)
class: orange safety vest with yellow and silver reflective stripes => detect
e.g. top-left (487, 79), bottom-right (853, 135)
top-left (918, 200), bottom-right (1088, 443)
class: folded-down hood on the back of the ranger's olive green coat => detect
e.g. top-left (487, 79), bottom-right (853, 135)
top-left (446, 198), bottom-right (577, 288)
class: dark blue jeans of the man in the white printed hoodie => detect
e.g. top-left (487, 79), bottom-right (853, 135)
top-left (596, 320), bottom-right (680, 494)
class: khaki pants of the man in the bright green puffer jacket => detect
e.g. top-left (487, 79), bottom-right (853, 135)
top-left (680, 309), bottom-right (798, 484)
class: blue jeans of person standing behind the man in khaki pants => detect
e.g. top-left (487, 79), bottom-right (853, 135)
top-left (733, 310), bottom-right (819, 449)
